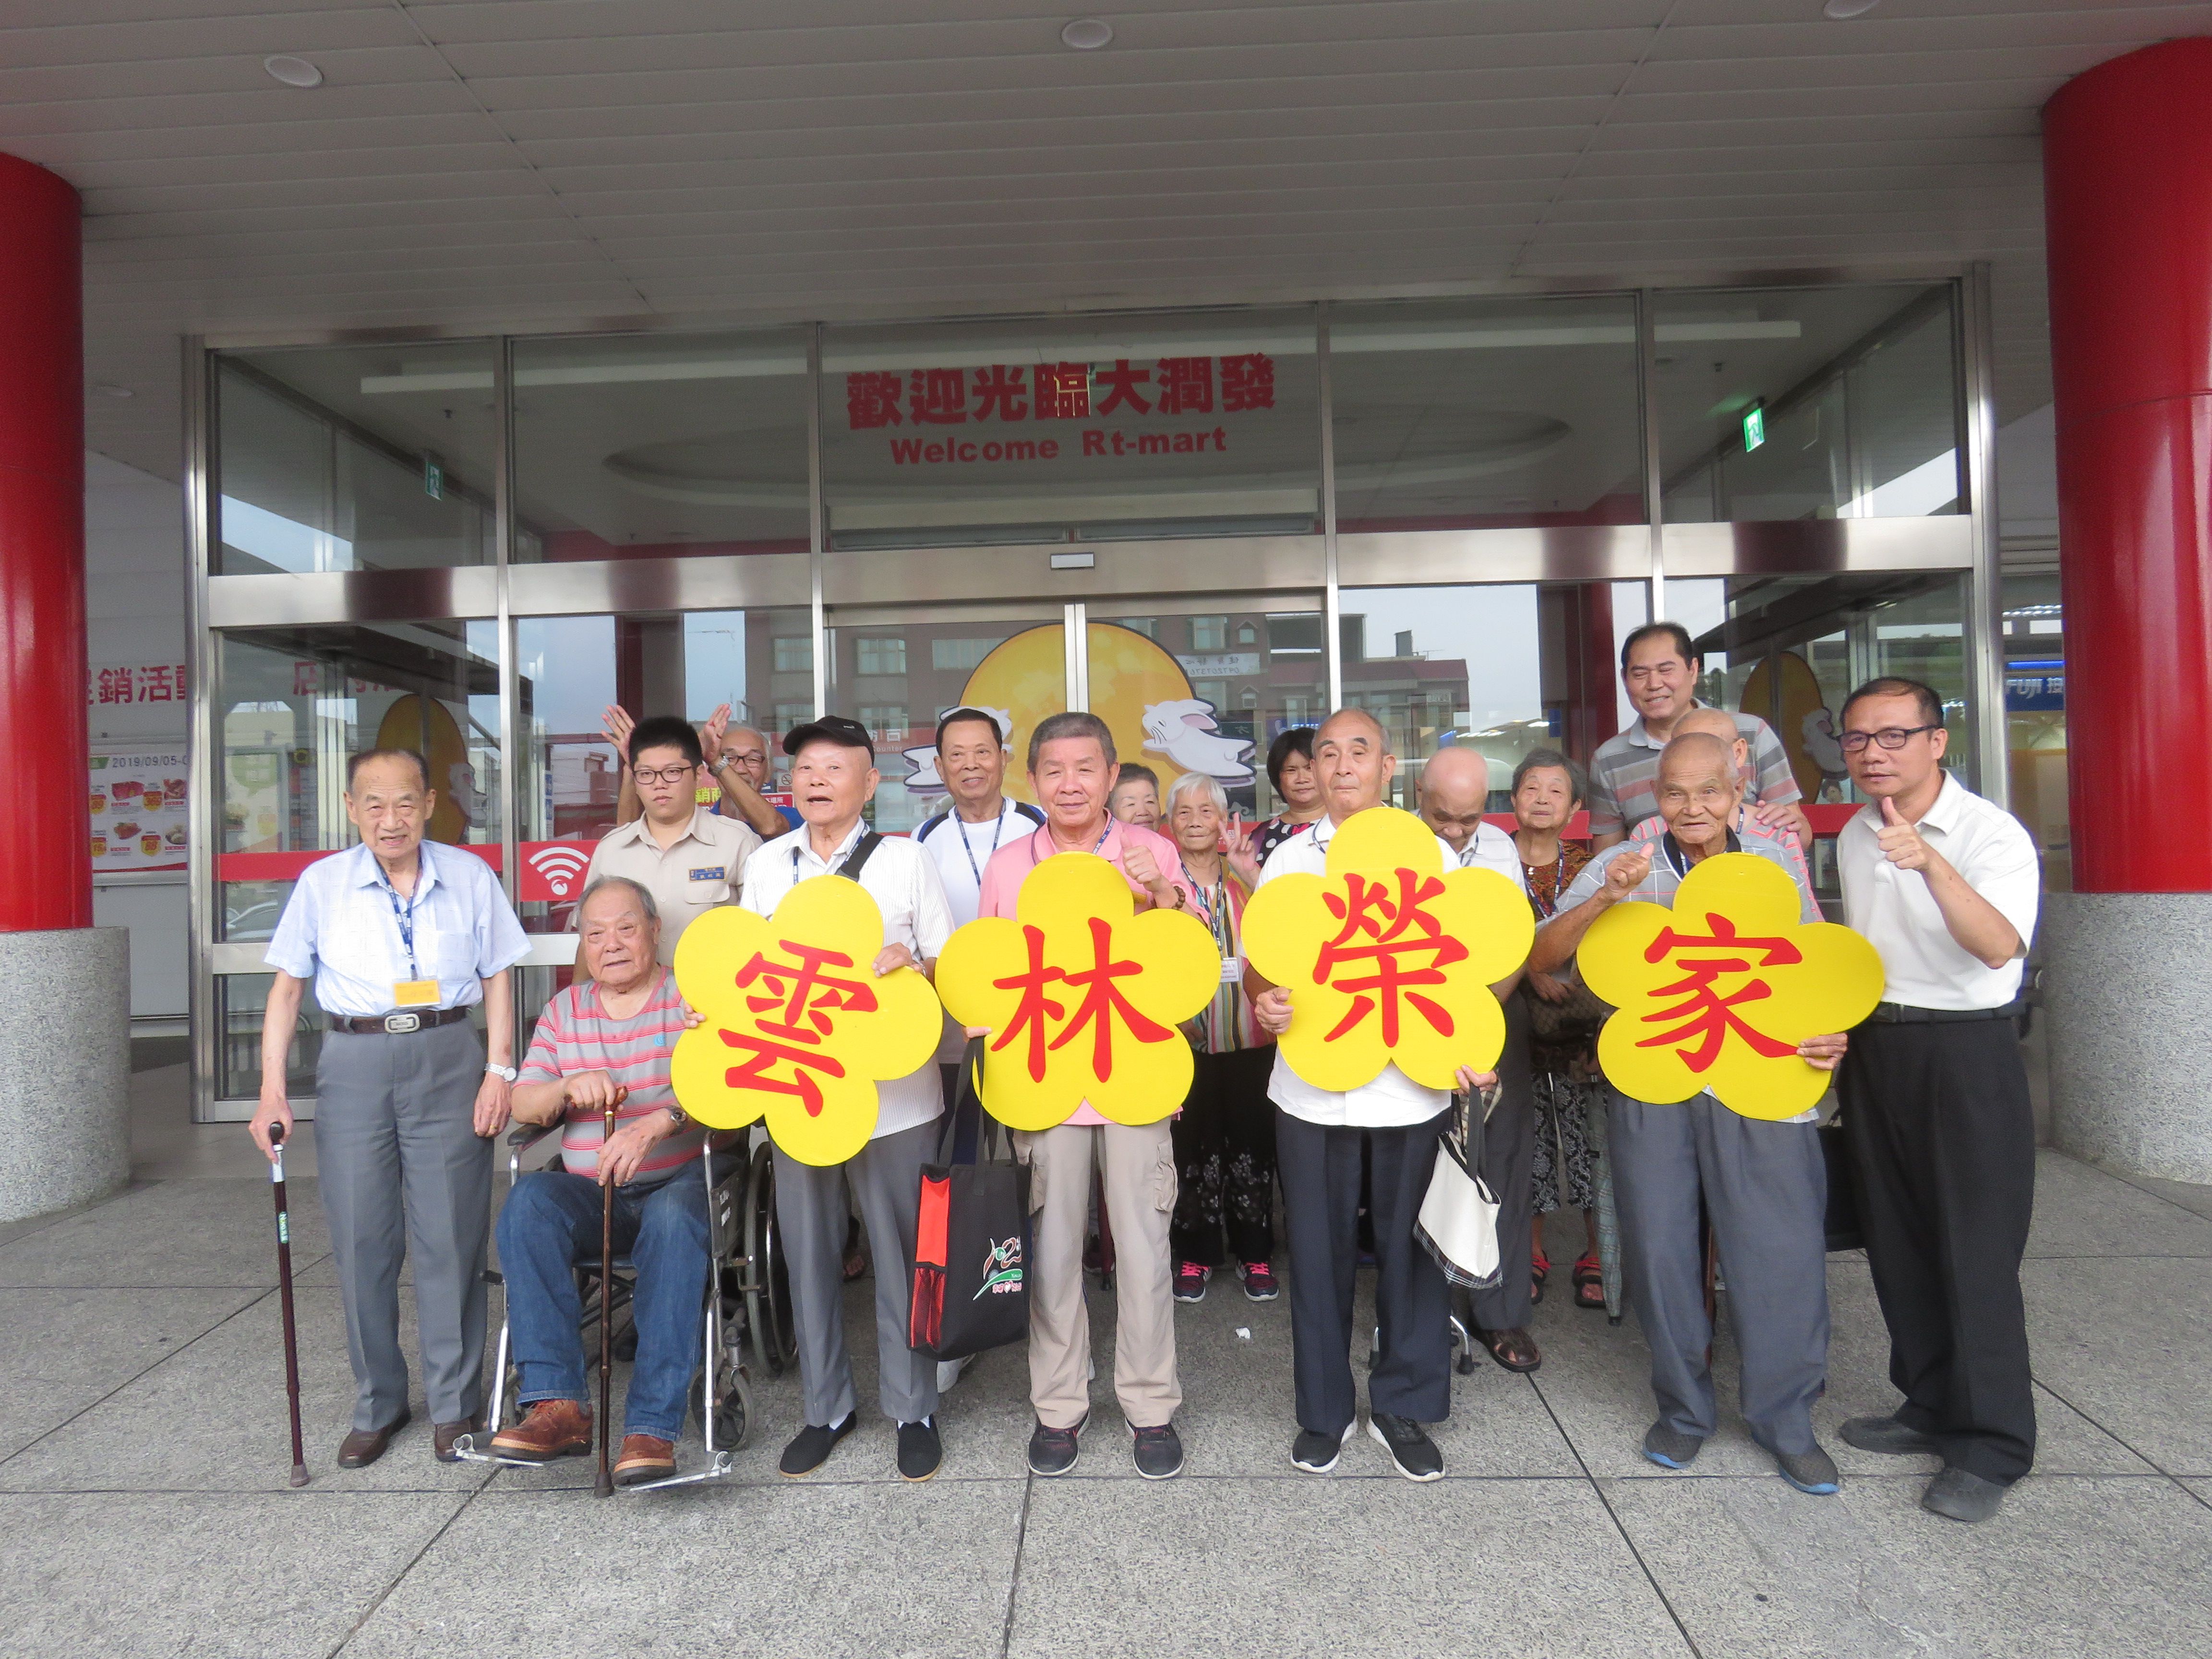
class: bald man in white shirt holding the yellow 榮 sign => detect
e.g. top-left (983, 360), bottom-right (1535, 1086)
top-left (1245, 708), bottom-right (1520, 1480)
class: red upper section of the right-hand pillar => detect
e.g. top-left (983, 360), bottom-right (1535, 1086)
top-left (2044, 40), bottom-right (2212, 894)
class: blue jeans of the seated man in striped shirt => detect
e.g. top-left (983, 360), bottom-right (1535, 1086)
top-left (500, 1164), bottom-right (708, 1440)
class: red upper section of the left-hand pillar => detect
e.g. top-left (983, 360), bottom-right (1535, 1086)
top-left (0, 155), bottom-right (93, 934)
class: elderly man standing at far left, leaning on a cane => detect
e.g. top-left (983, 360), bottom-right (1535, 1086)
top-left (252, 750), bottom-right (529, 1469)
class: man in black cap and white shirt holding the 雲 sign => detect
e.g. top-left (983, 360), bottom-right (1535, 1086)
top-left (743, 714), bottom-right (953, 1480)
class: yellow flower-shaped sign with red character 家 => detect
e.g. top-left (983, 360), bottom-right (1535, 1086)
top-left (1577, 852), bottom-right (1882, 1119)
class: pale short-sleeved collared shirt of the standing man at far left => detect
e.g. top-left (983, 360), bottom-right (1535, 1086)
top-left (268, 841), bottom-right (531, 1020)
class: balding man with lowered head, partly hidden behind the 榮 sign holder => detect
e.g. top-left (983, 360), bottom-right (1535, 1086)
top-left (1420, 748), bottom-right (1544, 1371)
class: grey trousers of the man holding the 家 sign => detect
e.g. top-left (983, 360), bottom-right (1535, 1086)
top-left (1606, 1088), bottom-right (1827, 1451)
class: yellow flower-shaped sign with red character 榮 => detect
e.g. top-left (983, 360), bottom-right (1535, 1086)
top-left (1243, 807), bottom-right (1535, 1093)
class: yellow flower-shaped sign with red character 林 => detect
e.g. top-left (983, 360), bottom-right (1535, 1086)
top-left (938, 852), bottom-right (1221, 1130)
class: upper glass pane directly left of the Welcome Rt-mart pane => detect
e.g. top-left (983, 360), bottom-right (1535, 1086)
top-left (513, 330), bottom-right (807, 562)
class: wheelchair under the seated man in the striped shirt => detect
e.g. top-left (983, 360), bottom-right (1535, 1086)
top-left (454, 1124), bottom-right (798, 1493)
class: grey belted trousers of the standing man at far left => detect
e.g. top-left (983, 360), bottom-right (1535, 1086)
top-left (314, 1022), bottom-right (491, 1429)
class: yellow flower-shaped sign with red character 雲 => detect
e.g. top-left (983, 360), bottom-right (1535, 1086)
top-left (670, 876), bottom-right (945, 1164)
